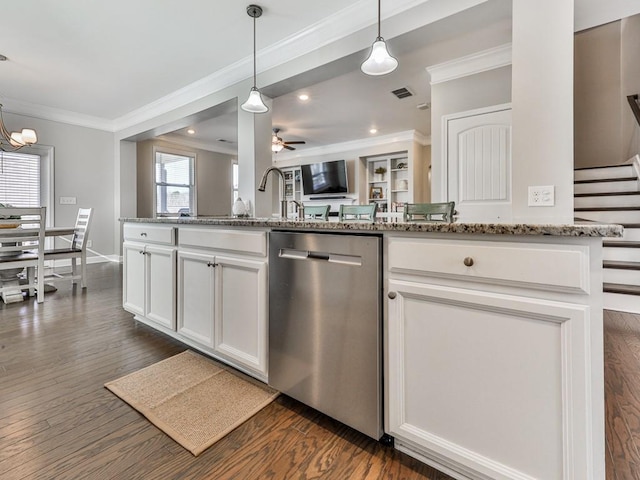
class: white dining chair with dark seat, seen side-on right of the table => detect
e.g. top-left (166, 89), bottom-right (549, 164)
top-left (43, 208), bottom-right (93, 288)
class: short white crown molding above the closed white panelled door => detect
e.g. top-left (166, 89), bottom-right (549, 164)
top-left (427, 43), bottom-right (512, 85)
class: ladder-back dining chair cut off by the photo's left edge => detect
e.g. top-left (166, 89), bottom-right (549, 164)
top-left (0, 207), bottom-right (47, 303)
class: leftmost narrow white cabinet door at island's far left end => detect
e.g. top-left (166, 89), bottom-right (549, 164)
top-left (122, 242), bottom-right (146, 316)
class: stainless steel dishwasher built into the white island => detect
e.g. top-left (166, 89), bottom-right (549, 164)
top-left (269, 231), bottom-right (383, 440)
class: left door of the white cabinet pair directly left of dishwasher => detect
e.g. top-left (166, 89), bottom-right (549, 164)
top-left (178, 251), bottom-right (216, 348)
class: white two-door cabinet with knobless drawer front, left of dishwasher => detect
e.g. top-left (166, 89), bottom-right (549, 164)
top-left (178, 227), bottom-right (267, 380)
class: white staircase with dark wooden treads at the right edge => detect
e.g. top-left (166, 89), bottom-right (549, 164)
top-left (574, 163), bottom-right (640, 313)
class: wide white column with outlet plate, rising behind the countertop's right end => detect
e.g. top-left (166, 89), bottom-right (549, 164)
top-left (512, 0), bottom-right (574, 223)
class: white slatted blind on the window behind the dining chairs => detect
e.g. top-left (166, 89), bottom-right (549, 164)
top-left (0, 152), bottom-right (41, 207)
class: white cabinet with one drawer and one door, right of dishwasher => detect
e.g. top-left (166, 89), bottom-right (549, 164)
top-left (387, 236), bottom-right (604, 480)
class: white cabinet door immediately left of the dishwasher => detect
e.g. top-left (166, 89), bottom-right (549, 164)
top-left (215, 256), bottom-right (267, 374)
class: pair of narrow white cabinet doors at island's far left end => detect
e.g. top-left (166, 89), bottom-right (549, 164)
top-left (123, 241), bottom-right (176, 330)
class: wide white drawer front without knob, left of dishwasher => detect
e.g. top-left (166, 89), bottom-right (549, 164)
top-left (178, 227), bottom-right (267, 257)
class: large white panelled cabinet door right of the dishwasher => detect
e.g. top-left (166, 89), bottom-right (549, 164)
top-left (387, 279), bottom-right (601, 480)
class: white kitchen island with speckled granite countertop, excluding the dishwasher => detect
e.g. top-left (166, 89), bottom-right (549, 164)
top-left (123, 218), bottom-right (622, 480)
